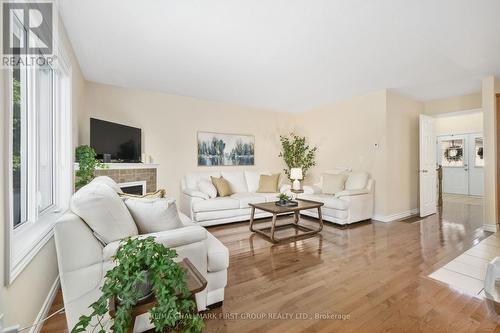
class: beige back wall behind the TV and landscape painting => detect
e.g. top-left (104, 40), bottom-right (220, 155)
top-left (80, 83), bottom-right (293, 202)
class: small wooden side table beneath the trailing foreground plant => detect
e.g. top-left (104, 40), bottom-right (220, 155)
top-left (109, 258), bottom-right (207, 333)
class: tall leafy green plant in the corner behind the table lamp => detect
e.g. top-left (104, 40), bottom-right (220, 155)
top-left (279, 133), bottom-right (318, 178)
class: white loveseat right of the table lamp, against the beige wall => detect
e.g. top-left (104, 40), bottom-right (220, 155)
top-left (298, 170), bottom-right (375, 225)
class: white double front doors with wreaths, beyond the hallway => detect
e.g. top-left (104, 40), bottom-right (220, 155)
top-left (436, 132), bottom-right (484, 196)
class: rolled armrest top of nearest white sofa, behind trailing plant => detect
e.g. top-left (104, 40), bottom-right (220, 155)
top-left (102, 226), bottom-right (207, 260)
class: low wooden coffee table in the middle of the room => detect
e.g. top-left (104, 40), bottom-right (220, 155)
top-left (248, 199), bottom-right (323, 243)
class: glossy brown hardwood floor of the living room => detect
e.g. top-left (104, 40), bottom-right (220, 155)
top-left (42, 197), bottom-right (500, 333)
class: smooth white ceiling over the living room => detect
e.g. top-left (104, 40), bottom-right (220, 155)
top-left (61, 0), bottom-right (500, 112)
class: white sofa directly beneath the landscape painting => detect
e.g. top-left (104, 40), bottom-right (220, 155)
top-left (180, 170), bottom-right (290, 226)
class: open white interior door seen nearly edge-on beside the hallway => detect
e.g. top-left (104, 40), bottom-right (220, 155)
top-left (419, 115), bottom-right (437, 217)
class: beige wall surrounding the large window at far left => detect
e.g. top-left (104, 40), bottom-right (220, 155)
top-left (0, 20), bottom-right (85, 326)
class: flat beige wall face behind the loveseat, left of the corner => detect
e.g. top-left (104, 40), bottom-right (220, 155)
top-left (297, 90), bottom-right (386, 211)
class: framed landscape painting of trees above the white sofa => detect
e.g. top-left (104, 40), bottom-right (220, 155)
top-left (197, 132), bottom-right (255, 166)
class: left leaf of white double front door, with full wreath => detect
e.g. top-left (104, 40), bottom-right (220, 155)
top-left (438, 135), bottom-right (469, 195)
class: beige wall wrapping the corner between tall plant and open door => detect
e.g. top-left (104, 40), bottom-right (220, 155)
top-left (297, 90), bottom-right (423, 216)
